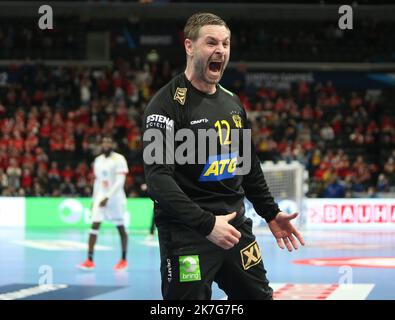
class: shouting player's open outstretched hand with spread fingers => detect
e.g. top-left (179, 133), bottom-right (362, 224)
top-left (268, 212), bottom-right (305, 252)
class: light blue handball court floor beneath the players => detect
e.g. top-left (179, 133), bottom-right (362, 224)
top-left (0, 228), bottom-right (395, 300)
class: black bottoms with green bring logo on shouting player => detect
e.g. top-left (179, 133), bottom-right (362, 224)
top-left (158, 219), bottom-right (273, 300)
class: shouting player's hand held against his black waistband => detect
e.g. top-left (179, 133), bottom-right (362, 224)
top-left (207, 212), bottom-right (241, 250)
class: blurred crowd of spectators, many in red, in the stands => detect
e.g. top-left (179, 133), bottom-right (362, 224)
top-left (0, 57), bottom-right (395, 197)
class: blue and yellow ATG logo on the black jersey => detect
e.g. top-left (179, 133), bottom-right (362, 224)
top-left (199, 153), bottom-right (237, 181)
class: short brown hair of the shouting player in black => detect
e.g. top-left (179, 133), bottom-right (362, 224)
top-left (184, 12), bottom-right (230, 41)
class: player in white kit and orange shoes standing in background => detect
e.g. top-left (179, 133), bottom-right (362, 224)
top-left (79, 136), bottom-right (128, 270)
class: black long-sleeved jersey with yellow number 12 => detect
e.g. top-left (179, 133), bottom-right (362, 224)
top-left (143, 73), bottom-right (279, 235)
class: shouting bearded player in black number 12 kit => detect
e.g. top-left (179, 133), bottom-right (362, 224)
top-left (143, 13), bottom-right (304, 300)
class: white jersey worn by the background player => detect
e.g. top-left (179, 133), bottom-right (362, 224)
top-left (93, 152), bottom-right (129, 201)
